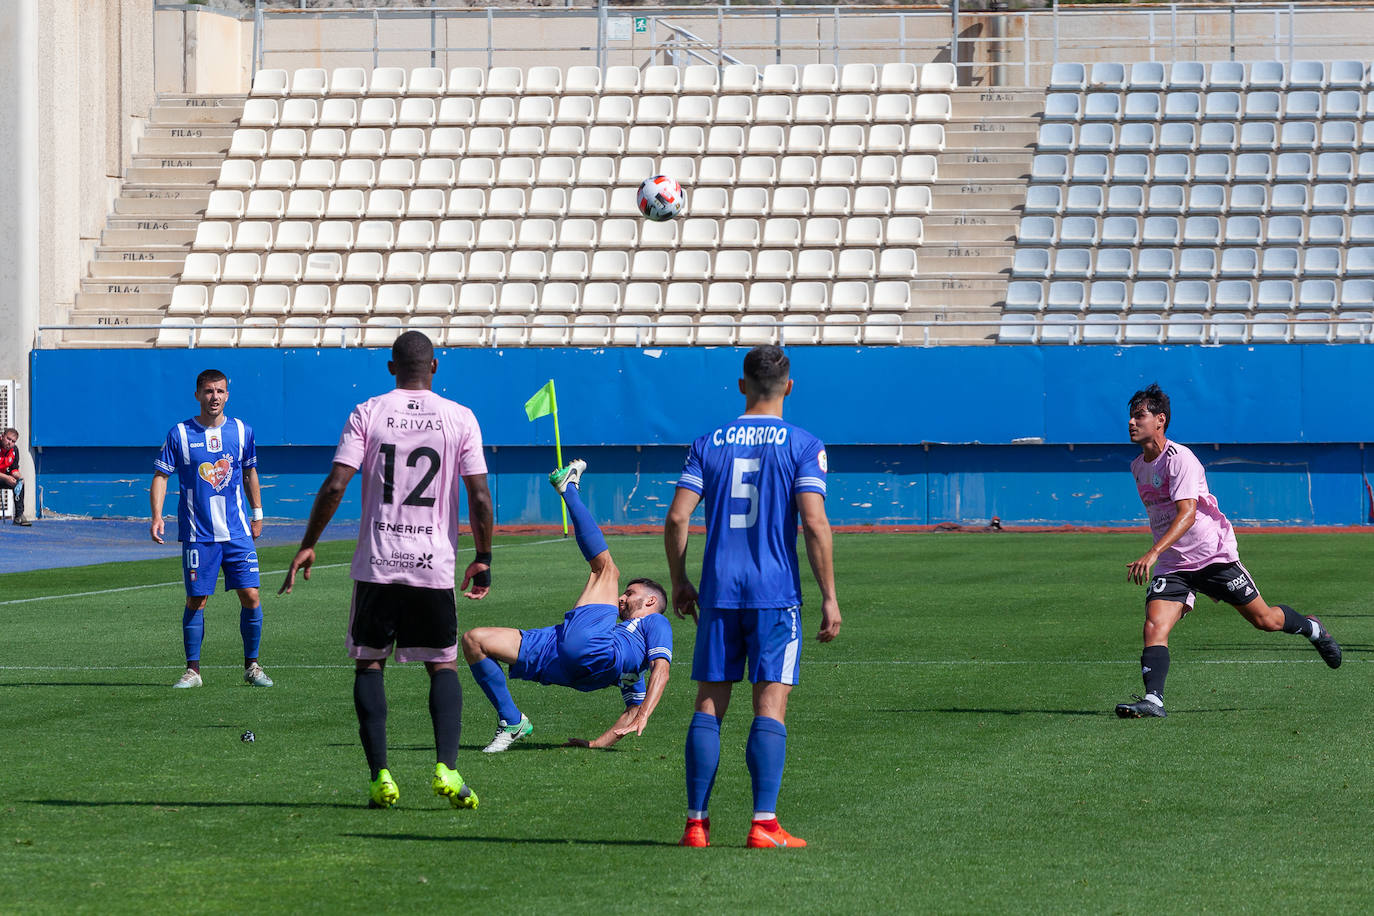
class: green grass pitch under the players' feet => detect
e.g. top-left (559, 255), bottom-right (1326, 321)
top-left (0, 533), bottom-right (1374, 913)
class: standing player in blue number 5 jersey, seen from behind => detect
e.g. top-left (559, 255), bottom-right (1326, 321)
top-left (664, 346), bottom-right (840, 849)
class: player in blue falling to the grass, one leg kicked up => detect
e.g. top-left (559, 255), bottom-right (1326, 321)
top-left (463, 459), bottom-right (673, 754)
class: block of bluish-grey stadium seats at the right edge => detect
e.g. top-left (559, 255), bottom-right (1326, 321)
top-left (998, 60), bottom-right (1374, 343)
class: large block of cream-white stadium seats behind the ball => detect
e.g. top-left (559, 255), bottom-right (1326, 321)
top-left (169, 63), bottom-right (956, 346)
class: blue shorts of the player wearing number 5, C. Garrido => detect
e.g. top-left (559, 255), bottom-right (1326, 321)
top-left (691, 607), bottom-right (801, 684)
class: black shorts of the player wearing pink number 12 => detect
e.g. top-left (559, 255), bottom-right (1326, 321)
top-left (348, 582), bottom-right (458, 662)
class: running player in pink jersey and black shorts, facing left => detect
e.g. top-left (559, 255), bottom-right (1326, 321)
top-left (1117, 385), bottom-right (1341, 718)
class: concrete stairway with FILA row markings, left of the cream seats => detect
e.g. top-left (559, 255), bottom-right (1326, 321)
top-left (62, 95), bottom-right (243, 346)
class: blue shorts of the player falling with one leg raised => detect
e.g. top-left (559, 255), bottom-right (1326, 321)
top-left (511, 604), bottom-right (620, 691)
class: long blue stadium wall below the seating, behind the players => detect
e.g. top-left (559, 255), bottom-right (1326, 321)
top-left (30, 345), bottom-right (1374, 526)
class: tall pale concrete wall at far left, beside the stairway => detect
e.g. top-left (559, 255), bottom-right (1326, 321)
top-left (0, 0), bottom-right (154, 519)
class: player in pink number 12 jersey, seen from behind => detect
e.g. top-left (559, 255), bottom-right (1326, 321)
top-left (279, 331), bottom-right (492, 808)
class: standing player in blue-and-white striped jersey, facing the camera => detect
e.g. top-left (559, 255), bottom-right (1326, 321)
top-left (148, 369), bottom-right (272, 687)
